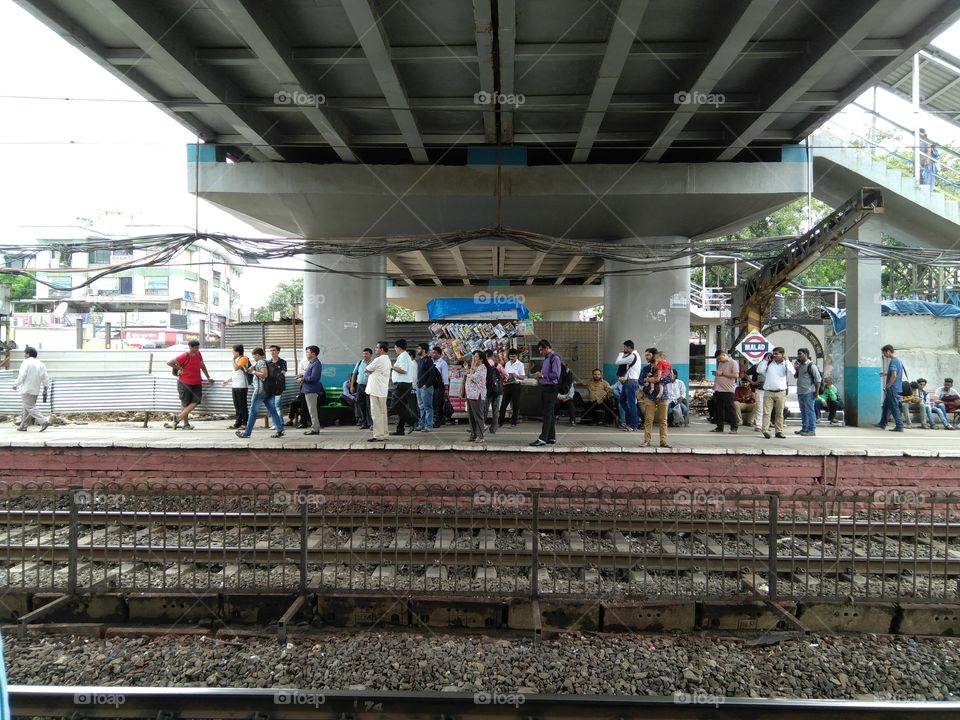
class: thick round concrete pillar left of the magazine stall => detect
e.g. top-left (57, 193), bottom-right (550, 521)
top-left (297, 255), bottom-right (387, 385)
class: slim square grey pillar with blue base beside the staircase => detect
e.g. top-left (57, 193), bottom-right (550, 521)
top-left (843, 236), bottom-right (883, 427)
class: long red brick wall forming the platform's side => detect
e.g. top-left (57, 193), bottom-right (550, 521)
top-left (0, 448), bottom-right (960, 493)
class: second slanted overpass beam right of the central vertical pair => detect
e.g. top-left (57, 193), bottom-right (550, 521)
top-left (643, 0), bottom-right (778, 162)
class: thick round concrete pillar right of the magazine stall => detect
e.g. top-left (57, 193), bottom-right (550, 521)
top-left (602, 253), bottom-right (690, 387)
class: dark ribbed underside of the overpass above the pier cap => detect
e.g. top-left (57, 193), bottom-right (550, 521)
top-left (15, 0), bottom-right (960, 165)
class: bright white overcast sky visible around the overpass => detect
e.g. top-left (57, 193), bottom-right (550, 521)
top-left (0, 0), bottom-right (960, 309)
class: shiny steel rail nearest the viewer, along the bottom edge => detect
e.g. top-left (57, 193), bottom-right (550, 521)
top-left (8, 685), bottom-right (960, 720)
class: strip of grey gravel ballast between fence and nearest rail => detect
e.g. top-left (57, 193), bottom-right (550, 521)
top-left (5, 632), bottom-right (960, 709)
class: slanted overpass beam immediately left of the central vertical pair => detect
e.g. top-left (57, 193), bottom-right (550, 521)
top-left (341, 0), bottom-right (429, 163)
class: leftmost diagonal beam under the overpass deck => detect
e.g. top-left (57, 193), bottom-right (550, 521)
top-left (88, 0), bottom-right (284, 160)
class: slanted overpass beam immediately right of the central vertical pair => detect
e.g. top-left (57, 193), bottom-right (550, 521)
top-left (573, 0), bottom-right (650, 163)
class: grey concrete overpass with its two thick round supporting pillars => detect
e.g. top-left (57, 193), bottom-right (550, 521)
top-left (15, 0), bottom-right (960, 416)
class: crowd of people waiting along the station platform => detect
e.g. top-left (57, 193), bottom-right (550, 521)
top-left (7, 339), bottom-right (960, 438)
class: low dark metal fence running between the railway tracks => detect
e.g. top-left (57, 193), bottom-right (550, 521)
top-left (0, 481), bottom-right (960, 600)
